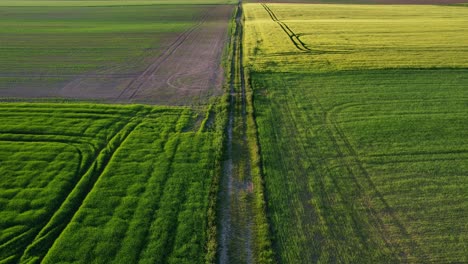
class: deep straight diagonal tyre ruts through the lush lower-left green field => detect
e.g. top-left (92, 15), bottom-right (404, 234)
top-left (20, 113), bottom-right (146, 262)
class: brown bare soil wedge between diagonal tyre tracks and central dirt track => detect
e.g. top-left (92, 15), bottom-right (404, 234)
top-left (117, 6), bottom-right (233, 104)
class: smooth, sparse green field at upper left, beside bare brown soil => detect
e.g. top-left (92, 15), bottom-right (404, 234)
top-left (0, 1), bottom-right (205, 91)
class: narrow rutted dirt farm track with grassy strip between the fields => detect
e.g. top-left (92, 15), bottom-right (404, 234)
top-left (219, 2), bottom-right (255, 263)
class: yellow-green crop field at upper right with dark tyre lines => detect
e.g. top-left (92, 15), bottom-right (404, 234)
top-left (245, 4), bottom-right (468, 71)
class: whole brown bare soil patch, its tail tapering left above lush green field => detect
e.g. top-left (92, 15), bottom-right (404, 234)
top-left (60, 5), bottom-right (232, 105)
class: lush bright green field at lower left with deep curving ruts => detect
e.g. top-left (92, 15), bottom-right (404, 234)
top-left (0, 103), bottom-right (222, 263)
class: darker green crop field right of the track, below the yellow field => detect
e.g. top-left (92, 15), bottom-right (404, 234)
top-left (252, 70), bottom-right (468, 263)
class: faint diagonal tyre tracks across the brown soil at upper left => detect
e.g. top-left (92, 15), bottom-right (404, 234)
top-left (117, 13), bottom-right (208, 100)
